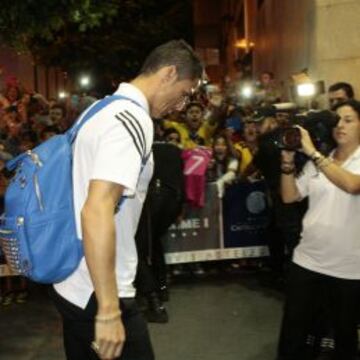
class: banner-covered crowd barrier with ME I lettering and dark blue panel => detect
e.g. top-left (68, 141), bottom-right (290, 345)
top-left (163, 182), bottom-right (268, 264)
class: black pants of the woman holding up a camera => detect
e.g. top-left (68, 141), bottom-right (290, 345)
top-left (278, 263), bottom-right (360, 360)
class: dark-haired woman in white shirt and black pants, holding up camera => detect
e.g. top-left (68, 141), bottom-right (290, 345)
top-left (278, 100), bottom-right (360, 360)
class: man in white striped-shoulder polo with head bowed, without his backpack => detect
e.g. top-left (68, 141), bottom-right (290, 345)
top-left (53, 40), bottom-right (203, 360)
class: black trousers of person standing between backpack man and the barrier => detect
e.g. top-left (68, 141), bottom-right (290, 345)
top-left (135, 188), bottom-right (181, 294)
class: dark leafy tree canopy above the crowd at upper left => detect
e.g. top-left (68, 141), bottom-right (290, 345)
top-left (0, 0), bottom-right (192, 90)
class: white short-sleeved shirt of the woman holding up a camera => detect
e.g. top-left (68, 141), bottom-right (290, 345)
top-left (293, 147), bottom-right (360, 279)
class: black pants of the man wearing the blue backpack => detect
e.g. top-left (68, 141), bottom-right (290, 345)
top-left (50, 288), bottom-right (154, 360)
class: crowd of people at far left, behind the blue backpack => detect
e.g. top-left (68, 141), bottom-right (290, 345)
top-left (0, 76), bottom-right (95, 306)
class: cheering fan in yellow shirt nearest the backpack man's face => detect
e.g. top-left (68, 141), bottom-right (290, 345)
top-left (164, 102), bottom-right (217, 150)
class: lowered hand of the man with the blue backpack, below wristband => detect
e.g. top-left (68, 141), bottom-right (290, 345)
top-left (95, 317), bottom-right (126, 360)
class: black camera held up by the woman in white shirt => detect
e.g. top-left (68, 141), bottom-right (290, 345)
top-left (275, 110), bottom-right (339, 154)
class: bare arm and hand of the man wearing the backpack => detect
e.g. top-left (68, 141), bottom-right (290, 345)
top-left (81, 180), bottom-right (125, 360)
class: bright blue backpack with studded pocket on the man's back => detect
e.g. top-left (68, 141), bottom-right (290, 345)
top-left (0, 95), bottom-right (137, 283)
